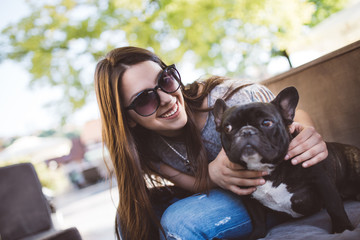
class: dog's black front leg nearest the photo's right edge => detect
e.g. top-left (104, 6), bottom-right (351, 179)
top-left (309, 163), bottom-right (354, 233)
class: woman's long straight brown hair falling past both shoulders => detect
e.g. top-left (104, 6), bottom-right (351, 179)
top-left (95, 47), bottom-right (223, 240)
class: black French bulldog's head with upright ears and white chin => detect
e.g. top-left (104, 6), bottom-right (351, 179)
top-left (213, 87), bottom-right (299, 171)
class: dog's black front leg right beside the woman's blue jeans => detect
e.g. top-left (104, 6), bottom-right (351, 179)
top-left (242, 196), bottom-right (266, 240)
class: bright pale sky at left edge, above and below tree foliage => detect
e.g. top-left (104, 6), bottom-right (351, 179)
top-left (0, 0), bottom-right (48, 137)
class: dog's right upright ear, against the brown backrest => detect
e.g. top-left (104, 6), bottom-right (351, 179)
top-left (271, 87), bottom-right (299, 125)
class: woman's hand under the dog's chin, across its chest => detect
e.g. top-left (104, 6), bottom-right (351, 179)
top-left (209, 149), bottom-right (267, 195)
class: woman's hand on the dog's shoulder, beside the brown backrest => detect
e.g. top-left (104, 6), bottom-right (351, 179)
top-left (285, 122), bottom-right (328, 168)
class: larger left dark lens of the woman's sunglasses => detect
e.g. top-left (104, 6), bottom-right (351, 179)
top-left (134, 91), bottom-right (159, 116)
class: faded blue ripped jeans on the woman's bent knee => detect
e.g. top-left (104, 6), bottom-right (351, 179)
top-left (160, 189), bottom-right (282, 240)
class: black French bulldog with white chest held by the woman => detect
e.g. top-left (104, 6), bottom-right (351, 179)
top-left (213, 87), bottom-right (360, 239)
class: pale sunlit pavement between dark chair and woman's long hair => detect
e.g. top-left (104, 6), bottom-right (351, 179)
top-left (52, 181), bottom-right (119, 240)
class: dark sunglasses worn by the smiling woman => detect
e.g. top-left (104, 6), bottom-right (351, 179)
top-left (125, 64), bottom-right (181, 117)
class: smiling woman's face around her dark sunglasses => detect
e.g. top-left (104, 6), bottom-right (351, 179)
top-left (121, 61), bottom-right (187, 137)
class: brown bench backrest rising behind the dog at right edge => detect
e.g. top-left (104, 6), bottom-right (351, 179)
top-left (262, 41), bottom-right (360, 148)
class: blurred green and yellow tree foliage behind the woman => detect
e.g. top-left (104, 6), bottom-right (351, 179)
top-left (0, 0), bottom-right (347, 124)
